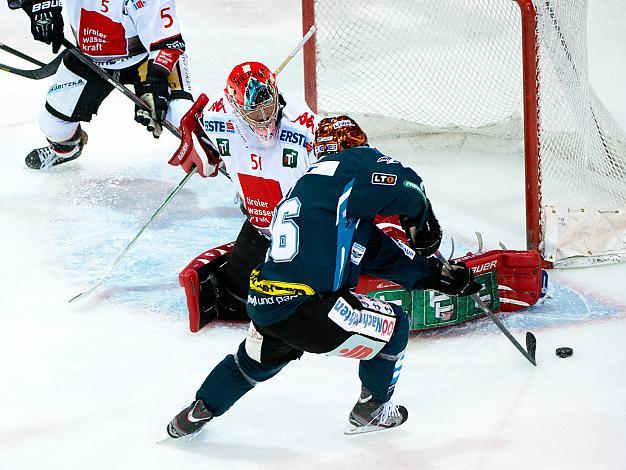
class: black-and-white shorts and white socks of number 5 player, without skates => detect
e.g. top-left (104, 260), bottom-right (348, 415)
top-left (39, 54), bottom-right (193, 142)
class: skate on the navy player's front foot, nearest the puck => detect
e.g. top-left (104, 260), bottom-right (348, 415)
top-left (344, 387), bottom-right (409, 434)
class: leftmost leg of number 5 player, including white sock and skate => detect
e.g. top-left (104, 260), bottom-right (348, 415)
top-left (25, 54), bottom-right (112, 169)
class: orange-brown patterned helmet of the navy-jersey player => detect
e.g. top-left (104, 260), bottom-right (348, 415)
top-left (315, 116), bottom-right (367, 158)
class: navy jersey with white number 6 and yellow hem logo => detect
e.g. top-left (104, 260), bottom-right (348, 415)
top-left (248, 147), bottom-right (432, 325)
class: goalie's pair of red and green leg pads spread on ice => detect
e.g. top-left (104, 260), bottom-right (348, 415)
top-left (179, 242), bottom-right (548, 333)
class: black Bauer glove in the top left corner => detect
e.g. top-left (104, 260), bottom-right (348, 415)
top-left (22, 0), bottom-right (63, 54)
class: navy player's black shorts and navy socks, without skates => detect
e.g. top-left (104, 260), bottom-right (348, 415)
top-left (196, 290), bottom-right (409, 416)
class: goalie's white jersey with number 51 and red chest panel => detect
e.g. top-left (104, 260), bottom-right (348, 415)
top-left (203, 93), bottom-right (318, 234)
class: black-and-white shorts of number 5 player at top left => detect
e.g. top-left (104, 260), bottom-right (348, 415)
top-left (46, 53), bottom-right (192, 122)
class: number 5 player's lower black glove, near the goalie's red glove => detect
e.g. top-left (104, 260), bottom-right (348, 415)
top-left (135, 61), bottom-right (170, 139)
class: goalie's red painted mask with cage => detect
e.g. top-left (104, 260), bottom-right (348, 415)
top-left (224, 62), bottom-right (281, 143)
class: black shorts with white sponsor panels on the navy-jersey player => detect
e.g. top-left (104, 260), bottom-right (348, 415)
top-left (245, 290), bottom-right (409, 363)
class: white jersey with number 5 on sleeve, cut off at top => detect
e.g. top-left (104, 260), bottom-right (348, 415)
top-left (64, 0), bottom-right (184, 69)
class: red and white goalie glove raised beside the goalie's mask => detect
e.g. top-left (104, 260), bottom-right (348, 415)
top-left (168, 93), bottom-right (222, 178)
